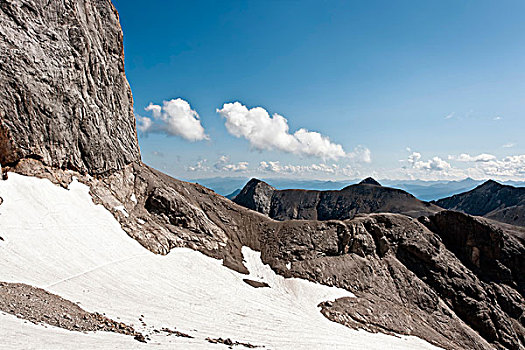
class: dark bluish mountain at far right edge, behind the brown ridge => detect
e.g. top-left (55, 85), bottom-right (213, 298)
top-left (434, 180), bottom-right (525, 226)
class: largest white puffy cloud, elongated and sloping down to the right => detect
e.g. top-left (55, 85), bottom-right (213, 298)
top-left (217, 102), bottom-right (347, 159)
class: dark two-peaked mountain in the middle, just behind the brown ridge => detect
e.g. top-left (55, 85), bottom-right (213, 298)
top-left (233, 178), bottom-right (440, 221)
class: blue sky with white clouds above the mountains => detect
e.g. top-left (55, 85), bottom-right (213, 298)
top-left (114, 0), bottom-right (525, 179)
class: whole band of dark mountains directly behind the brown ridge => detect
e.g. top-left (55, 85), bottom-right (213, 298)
top-left (227, 178), bottom-right (525, 226)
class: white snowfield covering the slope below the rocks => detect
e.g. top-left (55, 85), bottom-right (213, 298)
top-left (0, 174), bottom-right (442, 350)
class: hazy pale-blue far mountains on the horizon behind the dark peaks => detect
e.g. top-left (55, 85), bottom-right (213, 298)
top-left (188, 177), bottom-right (525, 201)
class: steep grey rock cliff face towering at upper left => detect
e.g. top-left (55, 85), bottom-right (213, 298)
top-left (0, 0), bottom-right (140, 174)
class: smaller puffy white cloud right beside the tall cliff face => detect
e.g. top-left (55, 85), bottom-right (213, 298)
top-left (137, 98), bottom-right (209, 142)
